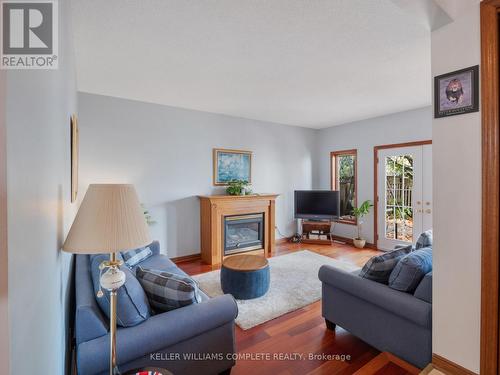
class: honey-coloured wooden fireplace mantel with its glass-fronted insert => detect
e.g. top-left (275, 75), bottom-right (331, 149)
top-left (199, 194), bottom-right (278, 265)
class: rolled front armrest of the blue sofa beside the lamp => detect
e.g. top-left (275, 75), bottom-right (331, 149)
top-left (78, 294), bottom-right (238, 374)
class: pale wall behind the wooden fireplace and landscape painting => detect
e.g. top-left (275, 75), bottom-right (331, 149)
top-left (78, 93), bottom-right (316, 257)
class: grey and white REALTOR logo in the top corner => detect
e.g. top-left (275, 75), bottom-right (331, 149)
top-left (0, 0), bottom-right (58, 69)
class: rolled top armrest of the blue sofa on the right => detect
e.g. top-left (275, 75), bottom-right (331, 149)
top-left (318, 265), bottom-right (432, 327)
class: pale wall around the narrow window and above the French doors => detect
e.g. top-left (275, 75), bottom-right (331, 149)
top-left (315, 107), bottom-right (432, 243)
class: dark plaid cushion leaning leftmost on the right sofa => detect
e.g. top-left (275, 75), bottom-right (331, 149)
top-left (359, 245), bottom-right (412, 284)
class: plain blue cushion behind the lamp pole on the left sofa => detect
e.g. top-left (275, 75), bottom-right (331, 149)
top-left (90, 254), bottom-right (151, 327)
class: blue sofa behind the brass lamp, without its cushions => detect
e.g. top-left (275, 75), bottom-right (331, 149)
top-left (75, 241), bottom-right (238, 375)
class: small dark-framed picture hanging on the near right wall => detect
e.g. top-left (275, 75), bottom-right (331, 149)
top-left (434, 65), bottom-right (479, 118)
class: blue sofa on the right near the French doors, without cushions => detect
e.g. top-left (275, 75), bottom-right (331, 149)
top-left (319, 265), bottom-right (432, 368)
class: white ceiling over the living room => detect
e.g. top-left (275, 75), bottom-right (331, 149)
top-left (72, 0), bottom-right (431, 128)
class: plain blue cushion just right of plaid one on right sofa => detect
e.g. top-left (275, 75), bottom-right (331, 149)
top-left (389, 247), bottom-right (432, 293)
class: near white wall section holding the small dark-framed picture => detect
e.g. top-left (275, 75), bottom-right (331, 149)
top-left (431, 0), bottom-right (481, 373)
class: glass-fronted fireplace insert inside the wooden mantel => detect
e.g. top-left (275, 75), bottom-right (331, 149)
top-left (223, 213), bottom-right (264, 255)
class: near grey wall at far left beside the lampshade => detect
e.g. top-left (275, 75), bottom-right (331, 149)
top-left (6, 1), bottom-right (76, 374)
